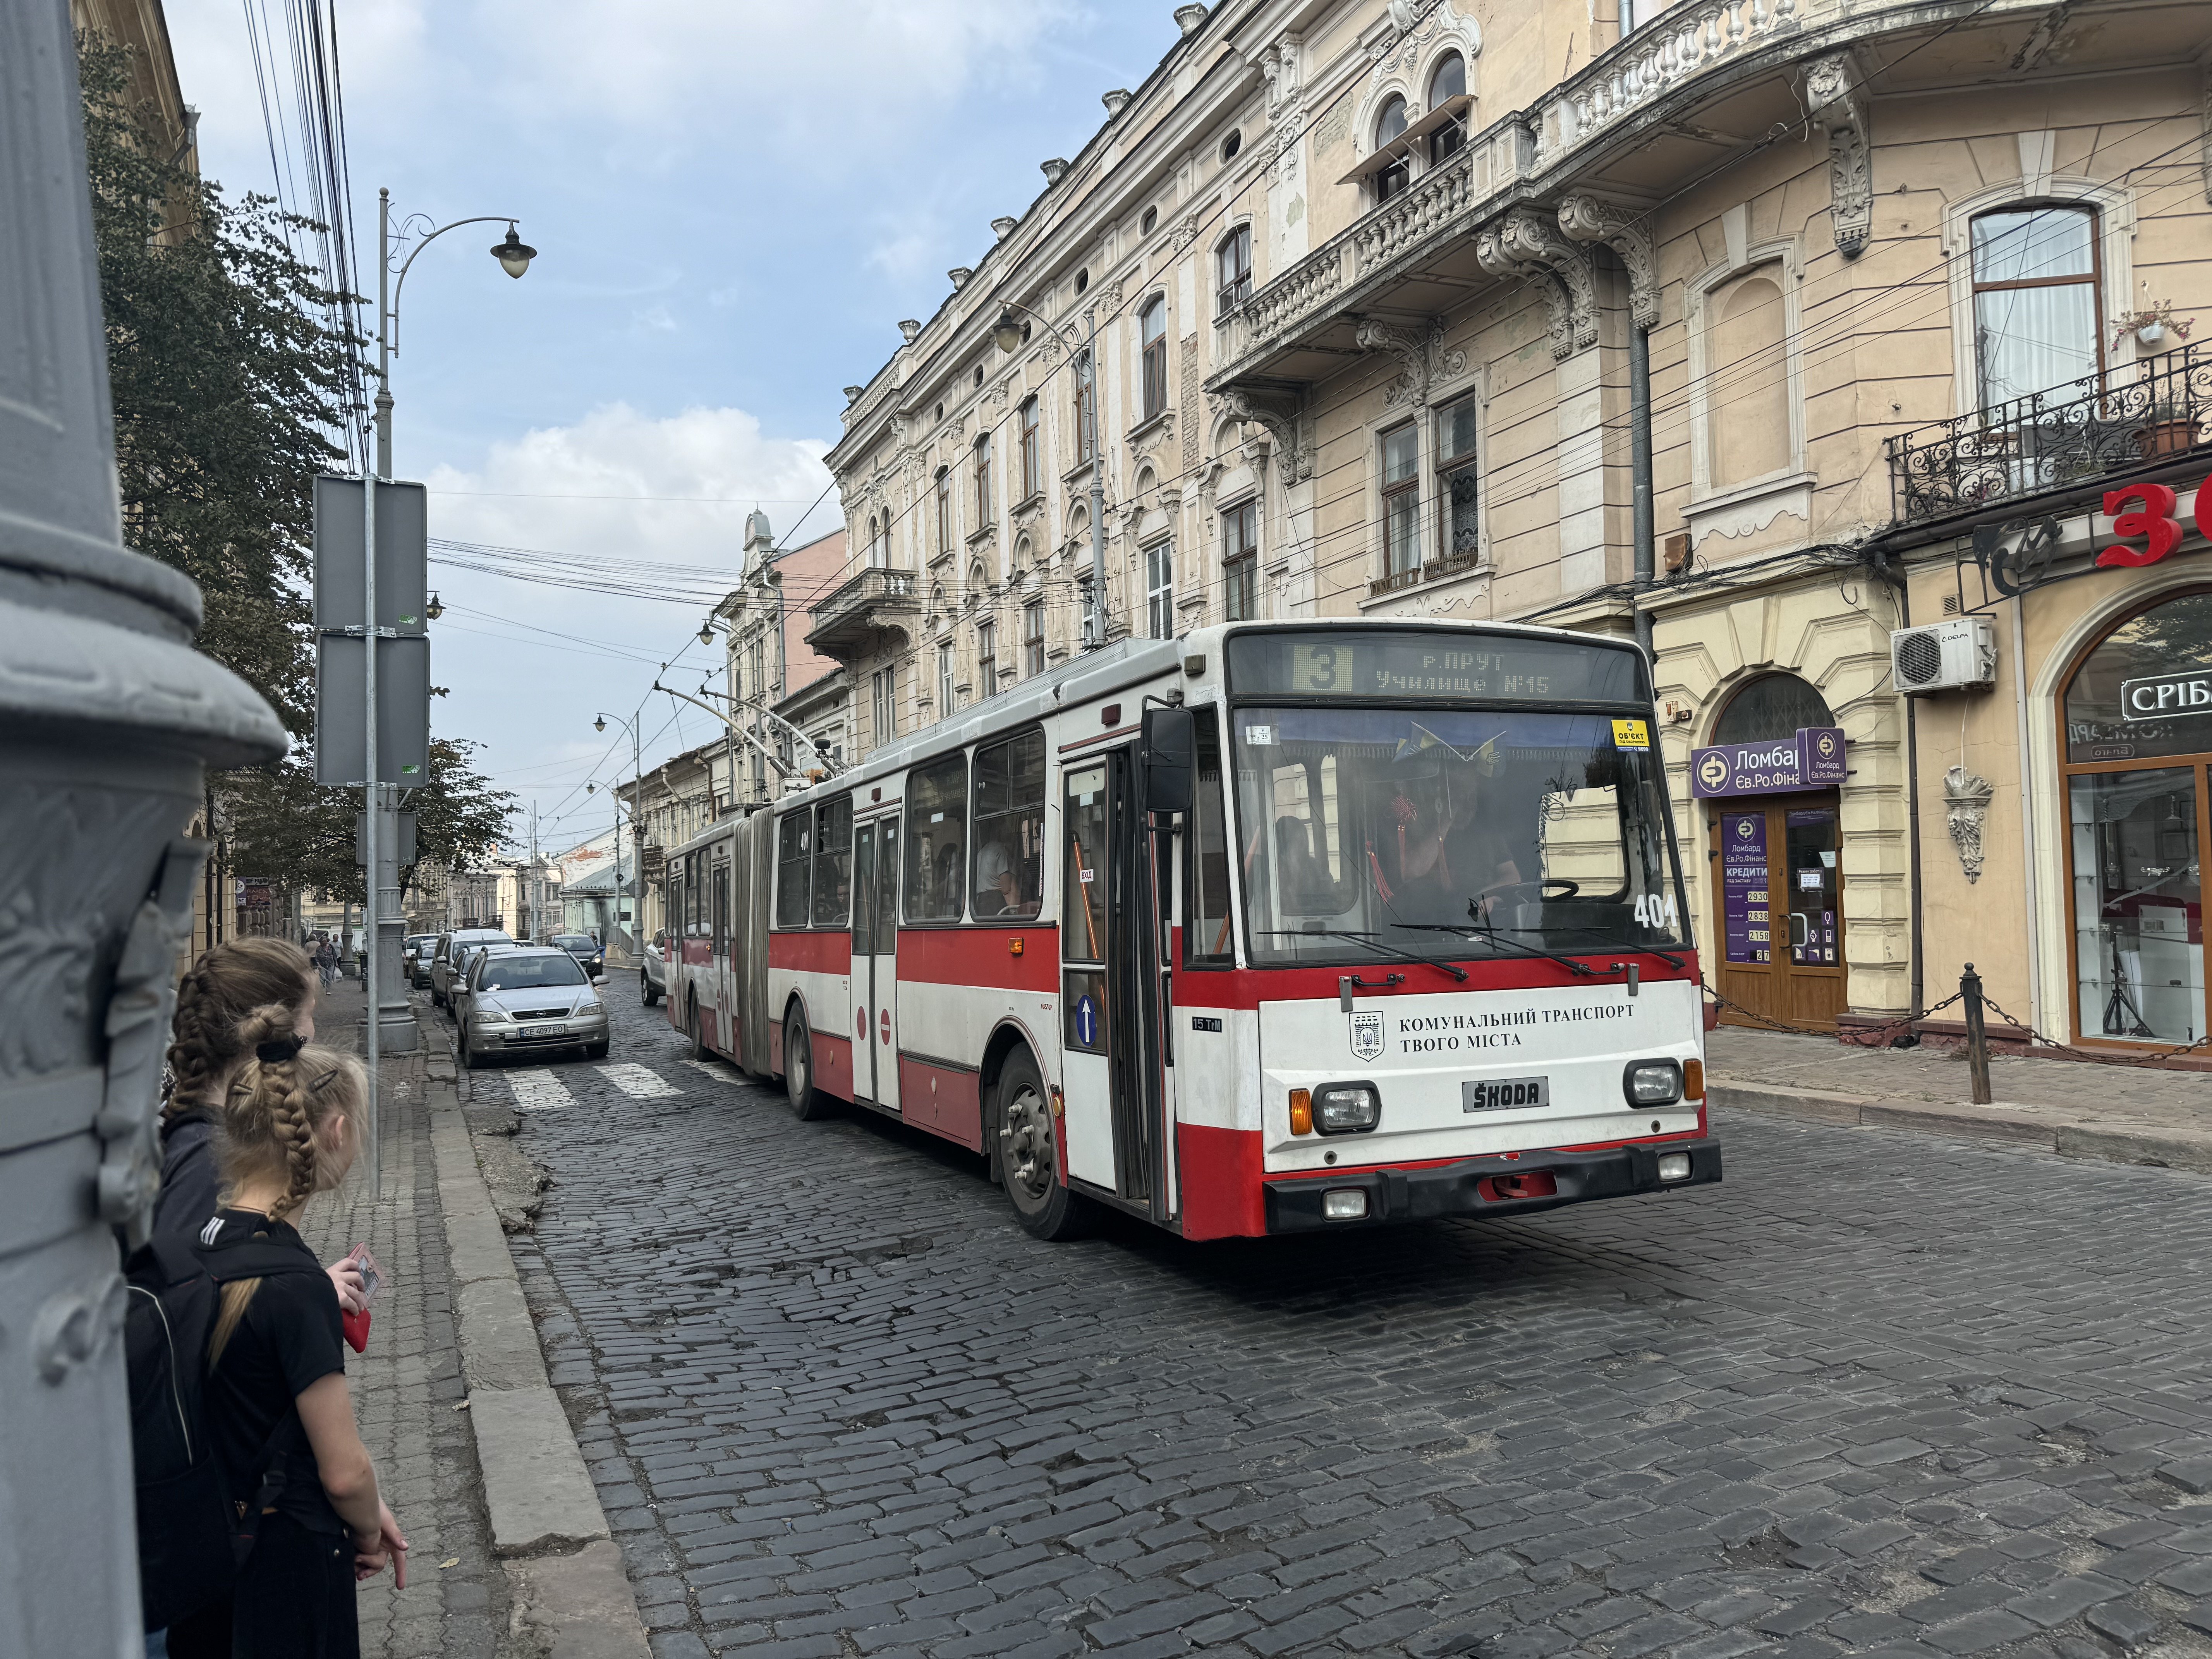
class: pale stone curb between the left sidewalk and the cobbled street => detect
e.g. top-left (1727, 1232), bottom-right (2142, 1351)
top-left (425, 1031), bottom-right (650, 1659)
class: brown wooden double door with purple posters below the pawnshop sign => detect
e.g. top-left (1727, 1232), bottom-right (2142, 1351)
top-left (1705, 794), bottom-right (1845, 1031)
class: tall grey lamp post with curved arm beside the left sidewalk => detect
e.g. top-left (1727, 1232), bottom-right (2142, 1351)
top-left (361, 190), bottom-right (538, 1168)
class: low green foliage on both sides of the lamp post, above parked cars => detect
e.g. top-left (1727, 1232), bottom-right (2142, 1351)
top-left (217, 737), bottom-right (515, 905)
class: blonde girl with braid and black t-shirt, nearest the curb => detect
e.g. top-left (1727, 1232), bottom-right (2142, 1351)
top-left (168, 1053), bottom-right (407, 1659)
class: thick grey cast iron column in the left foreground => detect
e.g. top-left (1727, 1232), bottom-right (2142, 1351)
top-left (0, 0), bottom-right (285, 1659)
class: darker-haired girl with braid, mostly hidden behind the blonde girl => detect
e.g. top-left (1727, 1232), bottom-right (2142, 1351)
top-left (153, 938), bottom-right (369, 1314)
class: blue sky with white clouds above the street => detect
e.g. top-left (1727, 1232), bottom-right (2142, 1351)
top-left (166, 0), bottom-right (1177, 847)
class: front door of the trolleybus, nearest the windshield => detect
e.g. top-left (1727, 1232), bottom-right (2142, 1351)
top-left (1060, 750), bottom-right (1161, 1206)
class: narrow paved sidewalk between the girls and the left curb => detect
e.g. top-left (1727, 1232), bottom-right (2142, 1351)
top-left (301, 980), bottom-right (509, 1659)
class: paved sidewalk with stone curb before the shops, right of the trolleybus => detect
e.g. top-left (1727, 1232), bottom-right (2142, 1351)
top-left (1705, 1026), bottom-right (2212, 1172)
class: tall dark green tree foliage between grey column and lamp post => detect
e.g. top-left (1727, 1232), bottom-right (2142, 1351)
top-left (77, 35), bottom-right (356, 737)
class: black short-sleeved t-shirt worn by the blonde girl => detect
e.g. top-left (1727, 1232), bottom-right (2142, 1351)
top-left (201, 1210), bottom-right (345, 1533)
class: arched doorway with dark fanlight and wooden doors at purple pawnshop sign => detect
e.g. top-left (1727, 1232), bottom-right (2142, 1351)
top-left (1705, 675), bottom-right (1845, 1031)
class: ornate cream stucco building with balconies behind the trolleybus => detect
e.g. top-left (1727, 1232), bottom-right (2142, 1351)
top-left (810, 0), bottom-right (2212, 1046)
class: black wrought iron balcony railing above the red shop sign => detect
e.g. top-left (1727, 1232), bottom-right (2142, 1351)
top-left (1882, 345), bottom-right (2212, 524)
